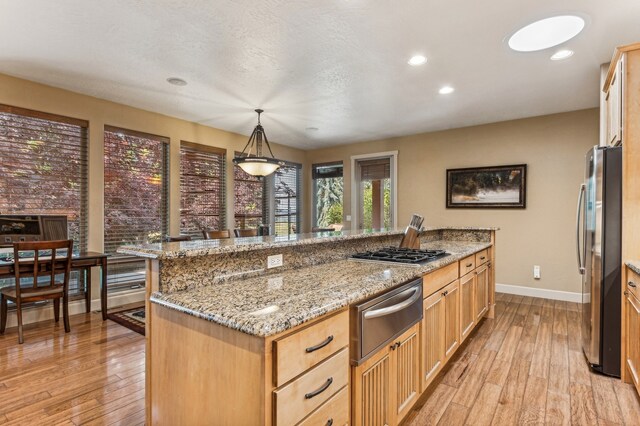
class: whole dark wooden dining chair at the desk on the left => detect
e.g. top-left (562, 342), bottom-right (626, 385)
top-left (0, 240), bottom-right (73, 344)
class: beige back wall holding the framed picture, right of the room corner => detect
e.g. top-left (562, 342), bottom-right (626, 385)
top-left (306, 109), bottom-right (599, 292)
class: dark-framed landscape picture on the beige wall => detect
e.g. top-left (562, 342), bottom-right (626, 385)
top-left (447, 164), bottom-right (527, 209)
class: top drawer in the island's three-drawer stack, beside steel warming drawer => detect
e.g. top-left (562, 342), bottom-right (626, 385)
top-left (273, 311), bottom-right (349, 387)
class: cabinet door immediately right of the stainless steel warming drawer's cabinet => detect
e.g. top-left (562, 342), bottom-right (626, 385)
top-left (422, 289), bottom-right (445, 391)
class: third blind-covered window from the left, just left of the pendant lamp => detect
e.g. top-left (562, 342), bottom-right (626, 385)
top-left (180, 141), bottom-right (227, 238)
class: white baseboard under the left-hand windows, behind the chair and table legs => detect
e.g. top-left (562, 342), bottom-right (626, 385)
top-left (1, 288), bottom-right (145, 327)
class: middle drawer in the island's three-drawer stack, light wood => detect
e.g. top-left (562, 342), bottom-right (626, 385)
top-left (273, 348), bottom-right (349, 425)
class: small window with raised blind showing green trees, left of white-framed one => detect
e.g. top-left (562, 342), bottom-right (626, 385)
top-left (311, 161), bottom-right (344, 229)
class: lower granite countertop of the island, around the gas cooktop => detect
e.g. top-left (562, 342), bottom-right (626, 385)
top-left (151, 241), bottom-right (491, 337)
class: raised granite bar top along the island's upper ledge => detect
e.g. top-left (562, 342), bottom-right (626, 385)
top-left (118, 226), bottom-right (498, 259)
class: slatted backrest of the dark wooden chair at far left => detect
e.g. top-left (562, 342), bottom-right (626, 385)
top-left (13, 240), bottom-right (73, 298)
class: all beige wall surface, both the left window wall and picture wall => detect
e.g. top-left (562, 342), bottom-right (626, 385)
top-left (0, 70), bottom-right (599, 294)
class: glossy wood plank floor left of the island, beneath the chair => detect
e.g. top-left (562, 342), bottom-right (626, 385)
top-left (0, 313), bottom-right (145, 425)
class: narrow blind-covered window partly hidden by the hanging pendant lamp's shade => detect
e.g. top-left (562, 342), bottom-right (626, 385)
top-left (233, 153), bottom-right (266, 229)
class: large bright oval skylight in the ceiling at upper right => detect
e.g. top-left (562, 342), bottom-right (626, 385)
top-left (509, 15), bottom-right (584, 52)
